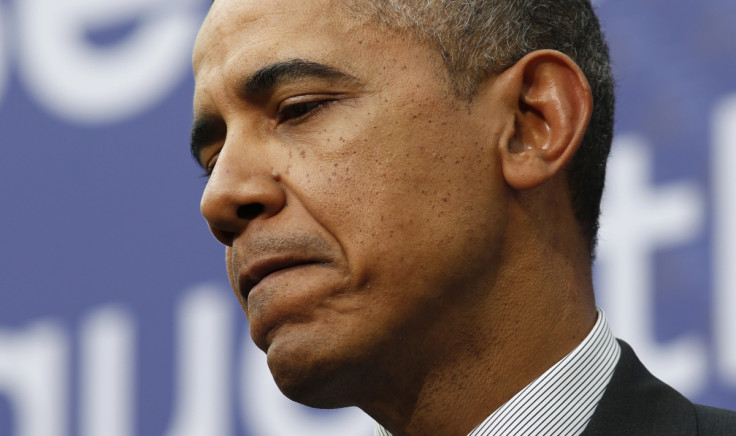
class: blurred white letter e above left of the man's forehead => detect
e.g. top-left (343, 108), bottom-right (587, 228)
top-left (15, 0), bottom-right (200, 124)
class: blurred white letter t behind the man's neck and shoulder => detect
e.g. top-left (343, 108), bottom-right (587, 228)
top-left (598, 136), bottom-right (707, 395)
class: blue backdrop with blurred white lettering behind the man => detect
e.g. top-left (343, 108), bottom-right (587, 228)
top-left (0, 0), bottom-right (736, 436)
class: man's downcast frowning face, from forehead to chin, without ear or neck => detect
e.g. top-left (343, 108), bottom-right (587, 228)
top-left (193, 0), bottom-right (508, 406)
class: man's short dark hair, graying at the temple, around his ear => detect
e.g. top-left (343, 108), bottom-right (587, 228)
top-left (354, 0), bottom-right (615, 257)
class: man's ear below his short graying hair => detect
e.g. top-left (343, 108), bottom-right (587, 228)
top-left (499, 50), bottom-right (593, 190)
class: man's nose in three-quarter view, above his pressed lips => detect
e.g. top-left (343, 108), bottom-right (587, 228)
top-left (200, 150), bottom-right (286, 246)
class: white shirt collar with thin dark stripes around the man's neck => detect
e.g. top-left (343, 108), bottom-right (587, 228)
top-left (374, 309), bottom-right (621, 436)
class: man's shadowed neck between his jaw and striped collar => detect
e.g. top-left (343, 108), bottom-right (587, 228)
top-left (360, 225), bottom-right (597, 436)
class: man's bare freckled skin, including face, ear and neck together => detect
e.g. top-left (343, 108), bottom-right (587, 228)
top-left (192, 0), bottom-right (596, 436)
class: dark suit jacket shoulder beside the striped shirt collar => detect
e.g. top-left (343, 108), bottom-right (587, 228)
top-left (583, 341), bottom-right (736, 436)
